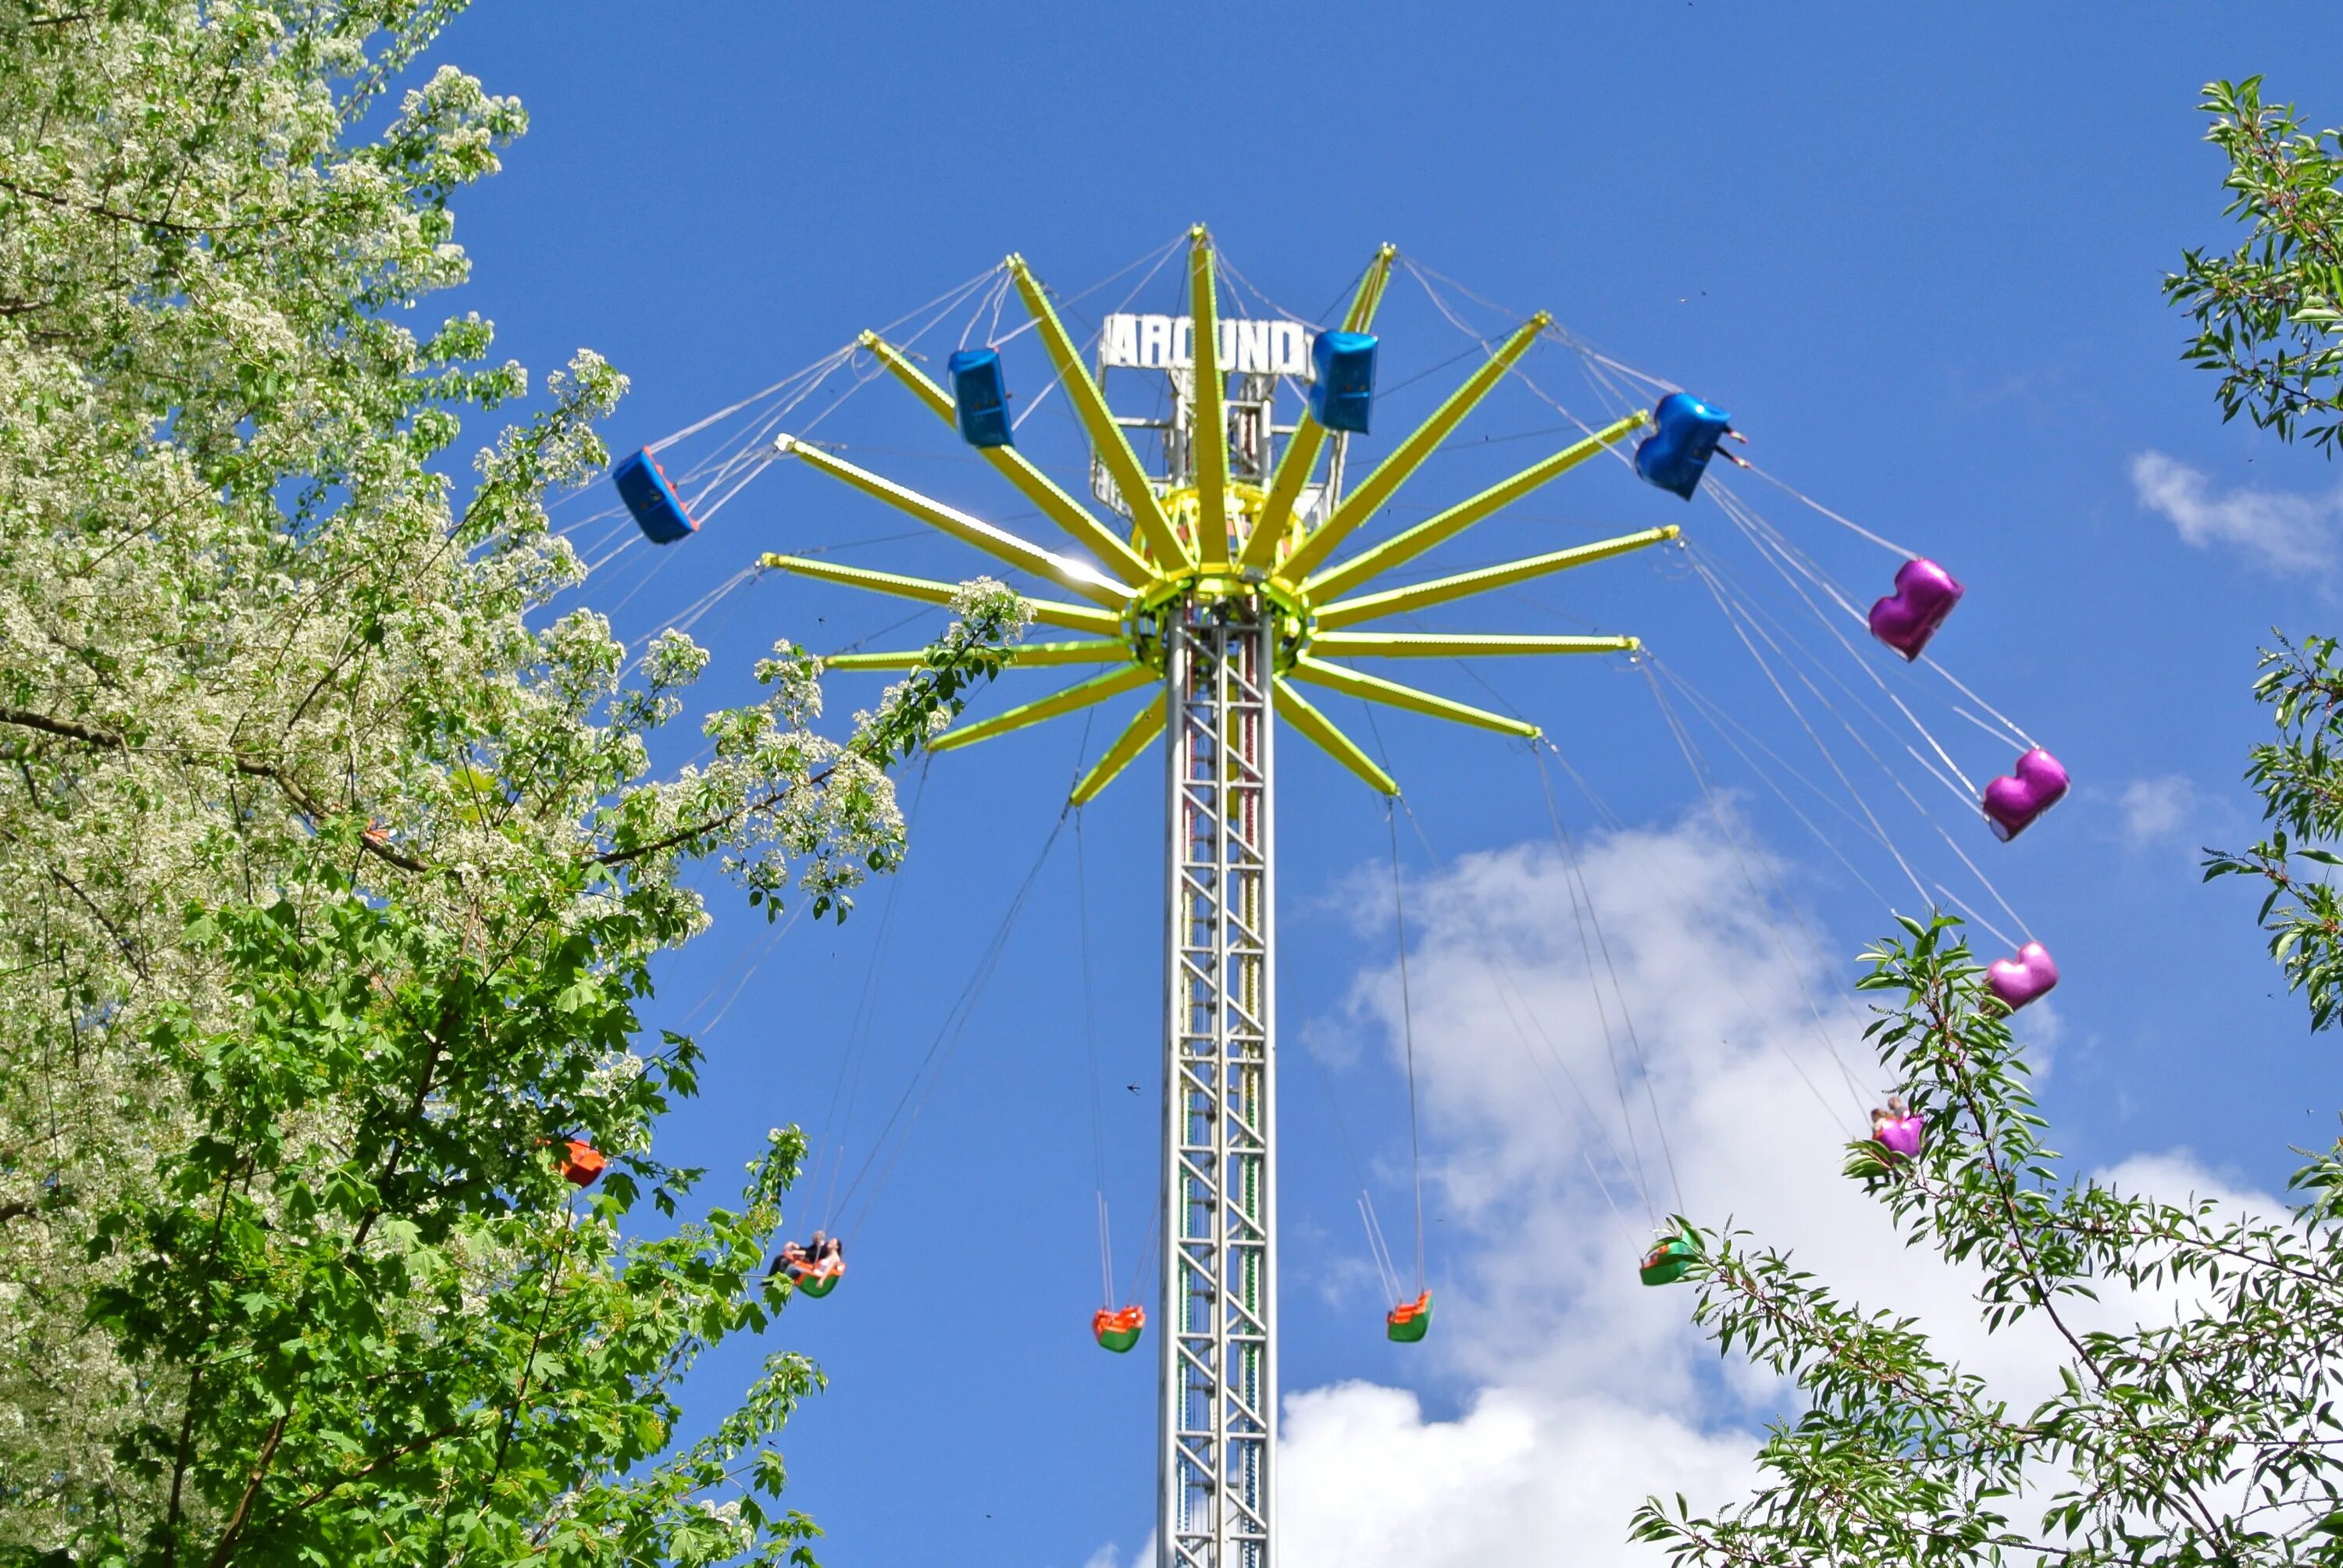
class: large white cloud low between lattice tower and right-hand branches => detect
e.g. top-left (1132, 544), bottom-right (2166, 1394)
top-left (1228, 818), bottom-right (2275, 1568)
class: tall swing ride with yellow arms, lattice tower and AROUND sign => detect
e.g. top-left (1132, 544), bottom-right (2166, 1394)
top-left (586, 227), bottom-right (2067, 1568)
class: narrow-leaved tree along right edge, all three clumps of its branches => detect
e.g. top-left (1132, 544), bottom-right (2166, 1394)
top-left (1633, 80), bottom-right (2343, 1568)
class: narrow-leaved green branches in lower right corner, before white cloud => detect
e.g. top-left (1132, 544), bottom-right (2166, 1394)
top-left (1635, 919), bottom-right (2343, 1566)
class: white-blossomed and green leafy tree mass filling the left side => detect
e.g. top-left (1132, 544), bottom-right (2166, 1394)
top-left (0, 0), bottom-right (1026, 1568)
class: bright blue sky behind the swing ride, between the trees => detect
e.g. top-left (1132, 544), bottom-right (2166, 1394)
top-left (438, 0), bottom-right (2343, 1568)
